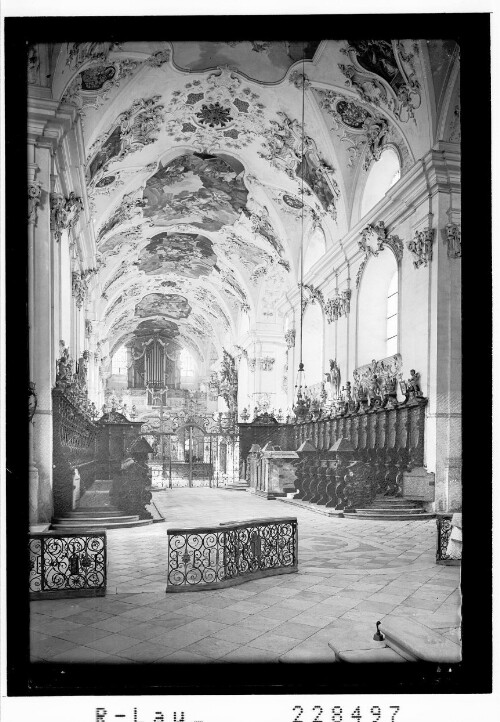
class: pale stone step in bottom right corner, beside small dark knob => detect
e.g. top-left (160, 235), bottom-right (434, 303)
top-left (380, 615), bottom-right (462, 663)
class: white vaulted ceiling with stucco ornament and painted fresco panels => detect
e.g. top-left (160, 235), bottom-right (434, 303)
top-left (48, 40), bottom-right (456, 362)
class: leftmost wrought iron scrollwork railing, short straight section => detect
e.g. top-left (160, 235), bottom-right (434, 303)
top-left (29, 530), bottom-right (106, 599)
